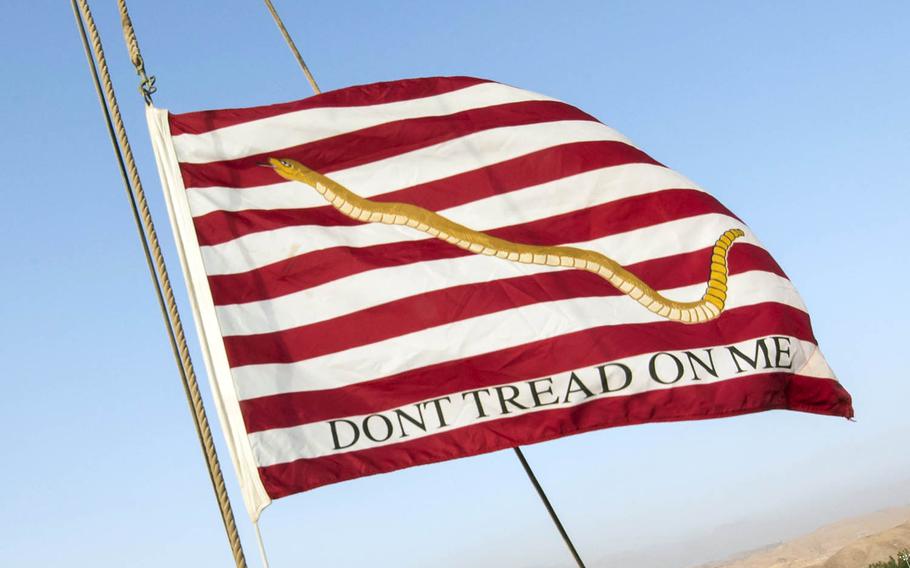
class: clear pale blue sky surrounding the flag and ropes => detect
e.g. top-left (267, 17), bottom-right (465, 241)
top-left (0, 0), bottom-right (910, 568)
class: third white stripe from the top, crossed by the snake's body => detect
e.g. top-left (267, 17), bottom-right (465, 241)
top-left (202, 164), bottom-right (700, 275)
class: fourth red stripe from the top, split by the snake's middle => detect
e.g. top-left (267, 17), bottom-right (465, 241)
top-left (209, 189), bottom-right (735, 305)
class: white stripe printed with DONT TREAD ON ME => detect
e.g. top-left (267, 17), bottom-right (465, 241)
top-left (250, 336), bottom-right (830, 467)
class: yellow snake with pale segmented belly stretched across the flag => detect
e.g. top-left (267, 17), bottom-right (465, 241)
top-left (269, 158), bottom-right (745, 323)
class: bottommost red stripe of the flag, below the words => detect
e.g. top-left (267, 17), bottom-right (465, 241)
top-left (259, 373), bottom-right (853, 499)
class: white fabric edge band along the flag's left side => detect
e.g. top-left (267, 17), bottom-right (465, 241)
top-left (145, 105), bottom-right (272, 523)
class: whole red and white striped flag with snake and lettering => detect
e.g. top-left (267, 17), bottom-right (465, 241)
top-left (148, 77), bottom-right (852, 518)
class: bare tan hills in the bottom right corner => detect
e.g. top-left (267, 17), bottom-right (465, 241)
top-left (699, 506), bottom-right (910, 568)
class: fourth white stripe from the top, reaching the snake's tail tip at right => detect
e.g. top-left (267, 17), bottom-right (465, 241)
top-left (216, 213), bottom-right (760, 336)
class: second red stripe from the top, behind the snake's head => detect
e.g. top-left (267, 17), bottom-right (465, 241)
top-left (180, 101), bottom-right (597, 189)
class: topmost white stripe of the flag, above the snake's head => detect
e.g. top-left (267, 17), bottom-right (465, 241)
top-left (173, 83), bottom-right (564, 164)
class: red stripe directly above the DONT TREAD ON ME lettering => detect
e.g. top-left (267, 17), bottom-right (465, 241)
top-left (240, 302), bottom-right (815, 432)
